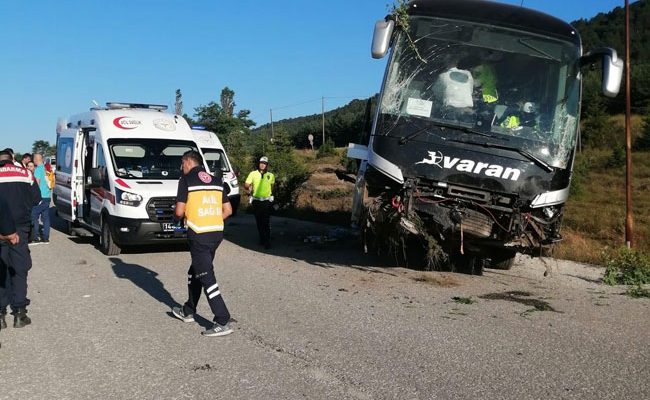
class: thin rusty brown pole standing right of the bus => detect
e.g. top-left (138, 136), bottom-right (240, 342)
top-left (625, 0), bottom-right (634, 249)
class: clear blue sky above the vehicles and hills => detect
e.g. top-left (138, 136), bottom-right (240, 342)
top-left (0, 0), bottom-right (624, 153)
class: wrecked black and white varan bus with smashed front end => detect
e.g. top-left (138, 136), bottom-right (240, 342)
top-left (348, 0), bottom-right (623, 273)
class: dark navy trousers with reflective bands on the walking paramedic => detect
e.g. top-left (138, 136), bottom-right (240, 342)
top-left (183, 229), bottom-right (230, 325)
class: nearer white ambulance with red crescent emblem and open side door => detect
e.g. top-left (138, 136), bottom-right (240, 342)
top-left (53, 103), bottom-right (204, 255)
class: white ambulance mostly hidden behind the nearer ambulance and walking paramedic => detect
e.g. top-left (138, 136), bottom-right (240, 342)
top-left (192, 130), bottom-right (240, 214)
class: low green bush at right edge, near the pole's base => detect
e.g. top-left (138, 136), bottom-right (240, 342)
top-left (602, 247), bottom-right (650, 285)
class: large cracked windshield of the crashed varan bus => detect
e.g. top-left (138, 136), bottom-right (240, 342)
top-left (380, 17), bottom-right (580, 168)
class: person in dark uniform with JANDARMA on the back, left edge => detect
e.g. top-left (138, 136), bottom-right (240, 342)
top-left (0, 151), bottom-right (41, 328)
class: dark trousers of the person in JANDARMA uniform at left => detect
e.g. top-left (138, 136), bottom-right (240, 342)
top-left (0, 226), bottom-right (32, 311)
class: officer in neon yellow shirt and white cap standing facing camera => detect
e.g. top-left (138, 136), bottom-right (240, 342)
top-left (244, 157), bottom-right (275, 249)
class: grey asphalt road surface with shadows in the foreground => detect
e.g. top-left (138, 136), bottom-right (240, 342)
top-left (0, 211), bottom-right (650, 399)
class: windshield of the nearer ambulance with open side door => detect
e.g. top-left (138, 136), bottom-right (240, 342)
top-left (108, 139), bottom-right (197, 179)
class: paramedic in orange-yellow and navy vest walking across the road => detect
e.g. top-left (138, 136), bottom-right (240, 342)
top-left (172, 150), bottom-right (232, 336)
